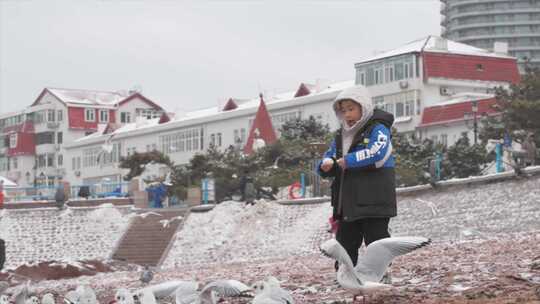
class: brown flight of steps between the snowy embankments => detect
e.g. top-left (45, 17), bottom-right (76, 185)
top-left (112, 208), bottom-right (189, 267)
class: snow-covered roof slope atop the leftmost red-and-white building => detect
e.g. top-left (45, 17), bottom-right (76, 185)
top-left (47, 88), bottom-right (129, 105)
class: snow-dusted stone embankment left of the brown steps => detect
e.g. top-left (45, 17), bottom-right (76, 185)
top-left (0, 204), bottom-right (131, 268)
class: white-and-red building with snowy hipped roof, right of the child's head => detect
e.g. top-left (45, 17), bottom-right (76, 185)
top-left (355, 36), bottom-right (520, 145)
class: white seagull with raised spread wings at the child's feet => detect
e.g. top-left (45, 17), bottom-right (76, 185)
top-left (321, 237), bottom-right (431, 302)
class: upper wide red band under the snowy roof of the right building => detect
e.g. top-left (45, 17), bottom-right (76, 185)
top-left (423, 52), bottom-right (520, 83)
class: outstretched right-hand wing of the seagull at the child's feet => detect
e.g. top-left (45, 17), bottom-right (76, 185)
top-left (355, 236), bottom-right (431, 282)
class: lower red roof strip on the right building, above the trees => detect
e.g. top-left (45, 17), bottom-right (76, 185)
top-left (419, 98), bottom-right (498, 127)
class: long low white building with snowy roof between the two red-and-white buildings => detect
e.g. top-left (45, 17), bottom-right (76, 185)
top-left (62, 81), bottom-right (354, 184)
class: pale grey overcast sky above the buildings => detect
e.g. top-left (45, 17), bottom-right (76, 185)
top-left (0, 0), bottom-right (440, 113)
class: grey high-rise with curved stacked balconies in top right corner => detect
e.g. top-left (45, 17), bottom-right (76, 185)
top-left (441, 0), bottom-right (540, 68)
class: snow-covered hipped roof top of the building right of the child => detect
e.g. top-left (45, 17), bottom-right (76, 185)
top-left (357, 35), bottom-right (513, 64)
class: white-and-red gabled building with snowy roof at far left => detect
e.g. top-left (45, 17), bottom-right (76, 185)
top-left (0, 88), bottom-right (164, 187)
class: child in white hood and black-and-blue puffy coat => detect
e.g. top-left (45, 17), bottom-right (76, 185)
top-left (318, 86), bottom-right (397, 274)
